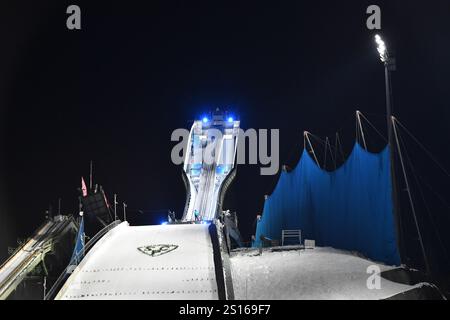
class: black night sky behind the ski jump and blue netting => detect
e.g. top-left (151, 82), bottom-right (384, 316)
top-left (0, 0), bottom-right (450, 276)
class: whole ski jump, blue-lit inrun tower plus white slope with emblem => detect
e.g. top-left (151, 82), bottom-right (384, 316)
top-left (56, 112), bottom-right (239, 300)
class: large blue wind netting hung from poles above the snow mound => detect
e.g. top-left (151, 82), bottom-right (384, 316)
top-left (254, 143), bottom-right (400, 265)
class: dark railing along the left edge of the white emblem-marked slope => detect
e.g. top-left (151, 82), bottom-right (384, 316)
top-left (44, 220), bottom-right (122, 300)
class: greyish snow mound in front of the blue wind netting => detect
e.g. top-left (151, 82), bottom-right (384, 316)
top-left (230, 247), bottom-right (414, 300)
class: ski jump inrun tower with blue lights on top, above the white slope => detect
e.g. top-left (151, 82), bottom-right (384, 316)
top-left (182, 110), bottom-right (239, 222)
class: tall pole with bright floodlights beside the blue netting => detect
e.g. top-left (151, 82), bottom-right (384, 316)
top-left (375, 34), bottom-right (405, 258)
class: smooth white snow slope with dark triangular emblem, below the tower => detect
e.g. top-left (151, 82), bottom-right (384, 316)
top-left (56, 222), bottom-right (223, 300)
